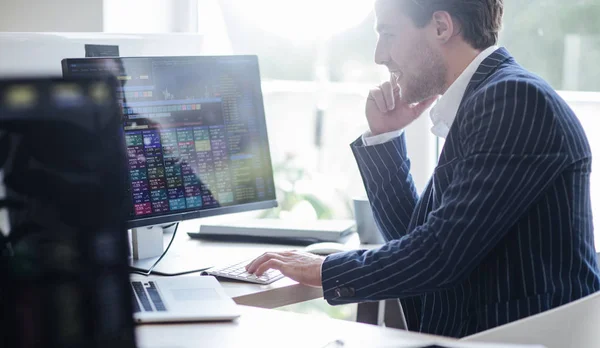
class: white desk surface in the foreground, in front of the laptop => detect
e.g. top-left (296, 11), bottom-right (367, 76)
top-left (136, 307), bottom-right (452, 348)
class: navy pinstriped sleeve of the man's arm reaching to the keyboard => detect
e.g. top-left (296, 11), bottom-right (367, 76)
top-left (322, 81), bottom-right (569, 304)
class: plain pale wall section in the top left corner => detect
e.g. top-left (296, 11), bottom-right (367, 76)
top-left (0, 0), bottom-right (103, 32)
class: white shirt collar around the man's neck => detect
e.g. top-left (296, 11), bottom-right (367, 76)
top-left (429, 46), bottom-right (498, 138)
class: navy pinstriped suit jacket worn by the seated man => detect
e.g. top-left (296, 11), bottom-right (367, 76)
top-left (322, 48), bottom-right (600, 337)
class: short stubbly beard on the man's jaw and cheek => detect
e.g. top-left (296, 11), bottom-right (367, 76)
top-left (400, 41), bottom-right (447, 104)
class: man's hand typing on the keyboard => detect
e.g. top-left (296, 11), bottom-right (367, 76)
top-left (246, 251), bottom-right (325, 287)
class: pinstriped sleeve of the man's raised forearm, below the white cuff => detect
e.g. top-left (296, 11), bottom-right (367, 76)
top-left (352, 133), bottom-right (419, 241)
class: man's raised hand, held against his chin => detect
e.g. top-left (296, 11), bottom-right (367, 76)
top-left (366, 81), bottom-right (438, 135)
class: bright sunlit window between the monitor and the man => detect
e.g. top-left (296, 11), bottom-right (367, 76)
top-left (219, 0), bottom-right (435, 223)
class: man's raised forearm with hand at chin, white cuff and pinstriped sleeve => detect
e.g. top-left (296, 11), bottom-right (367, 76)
top-left (352, 81), bottom-right (437, 241)
